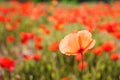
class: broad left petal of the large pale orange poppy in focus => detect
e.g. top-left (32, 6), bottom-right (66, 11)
top-left (59, 33), bottom-right (80, 55)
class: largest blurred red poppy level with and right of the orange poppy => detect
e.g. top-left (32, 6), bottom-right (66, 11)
top-left (102, 41), bottom-right (116, 52)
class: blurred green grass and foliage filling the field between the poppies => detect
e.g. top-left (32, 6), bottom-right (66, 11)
top-left (0, 0), bottom-right (120, 80)
